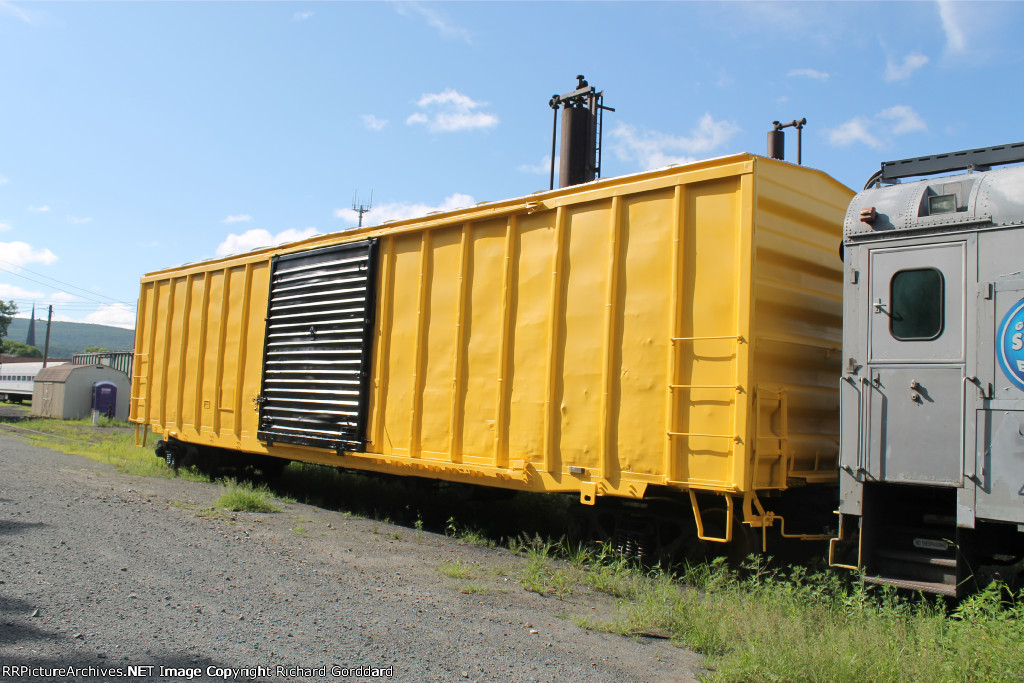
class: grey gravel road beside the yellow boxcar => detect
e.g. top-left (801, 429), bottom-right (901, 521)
top-left (0, 425), bottom-right (702, 683)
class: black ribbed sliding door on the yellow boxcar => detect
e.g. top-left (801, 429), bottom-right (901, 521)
top-left (258, 240), bottom-right (377, 452)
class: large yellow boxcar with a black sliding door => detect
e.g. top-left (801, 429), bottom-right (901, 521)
top-left (131, 154), bottom-right (853, 540)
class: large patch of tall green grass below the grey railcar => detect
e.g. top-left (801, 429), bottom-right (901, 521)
top-left (577, 560), bottom-right (1024, 683)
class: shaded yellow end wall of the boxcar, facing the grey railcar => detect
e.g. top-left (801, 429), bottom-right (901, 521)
top-left (752, 160), bottom-right (852, 488)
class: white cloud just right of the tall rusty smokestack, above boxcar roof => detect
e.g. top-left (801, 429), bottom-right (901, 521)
top-left (611, 113), bottom-right (739, 169)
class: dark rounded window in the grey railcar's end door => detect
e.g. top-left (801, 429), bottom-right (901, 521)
top-left (889, 268), bottom-right (945, 341)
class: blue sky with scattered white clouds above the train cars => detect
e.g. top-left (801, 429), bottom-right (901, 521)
top-left (0, 0), bottom-right (1024, 328)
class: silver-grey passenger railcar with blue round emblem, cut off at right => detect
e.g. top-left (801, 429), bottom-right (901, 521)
top-left (831, 143), bottom-right (1024, 595)
